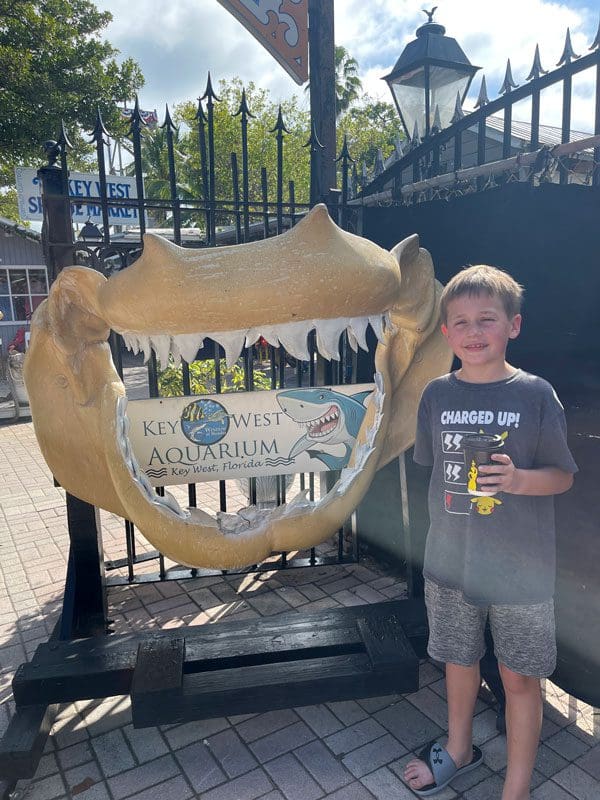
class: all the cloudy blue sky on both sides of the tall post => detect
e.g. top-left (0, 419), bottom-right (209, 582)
top-left (96, 0), bottom-right (600, 131)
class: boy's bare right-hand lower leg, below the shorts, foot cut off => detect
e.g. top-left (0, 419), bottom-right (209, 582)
top-left (500, 664), bottom-right (542, 800)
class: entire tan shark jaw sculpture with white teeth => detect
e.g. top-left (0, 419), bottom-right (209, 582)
top-left (25, 206), bottom-right (450, 569)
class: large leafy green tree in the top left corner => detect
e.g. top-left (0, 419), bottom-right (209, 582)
top-left (0, 0), bottom-right (144, 186)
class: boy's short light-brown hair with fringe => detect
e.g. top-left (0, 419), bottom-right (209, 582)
top-left (440, 264), bottom-right (523, 325)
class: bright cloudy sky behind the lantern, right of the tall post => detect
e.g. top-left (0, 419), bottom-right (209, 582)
top-left (336, 0), bottom-right (598, 130)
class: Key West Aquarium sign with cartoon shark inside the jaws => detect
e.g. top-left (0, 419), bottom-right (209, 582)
top-left (127, 384), bottom-right (373, 486)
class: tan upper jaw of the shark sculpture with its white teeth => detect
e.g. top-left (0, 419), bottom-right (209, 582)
top-left (99, 206), bottom-right (400, 364)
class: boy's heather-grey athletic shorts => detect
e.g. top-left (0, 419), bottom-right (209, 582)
top-left (425, 579), bottom-right (556, 678)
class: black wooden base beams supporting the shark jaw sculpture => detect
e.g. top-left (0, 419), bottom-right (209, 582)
top-left (0, 600), bottom-right (427, 780)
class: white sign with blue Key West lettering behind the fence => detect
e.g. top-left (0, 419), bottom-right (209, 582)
top-left (15, 167), bottom-right (139, 226)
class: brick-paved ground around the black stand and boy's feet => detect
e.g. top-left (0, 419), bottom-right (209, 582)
top-left (0, 423), bottom-right (600, 800)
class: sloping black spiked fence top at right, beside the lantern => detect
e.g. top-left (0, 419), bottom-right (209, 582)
top-left (361, 28), bottom-right (600, 205)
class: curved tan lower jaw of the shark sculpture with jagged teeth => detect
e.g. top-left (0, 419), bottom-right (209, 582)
top-left (101, 316), bottom-right (390, 569)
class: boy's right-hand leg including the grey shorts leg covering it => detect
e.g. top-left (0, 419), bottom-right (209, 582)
top-left (490, 600), bottom-right (556, 800)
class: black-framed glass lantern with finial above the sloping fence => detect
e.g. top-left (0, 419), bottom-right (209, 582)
top-left (384, 8), bottom-right (480, 139)
